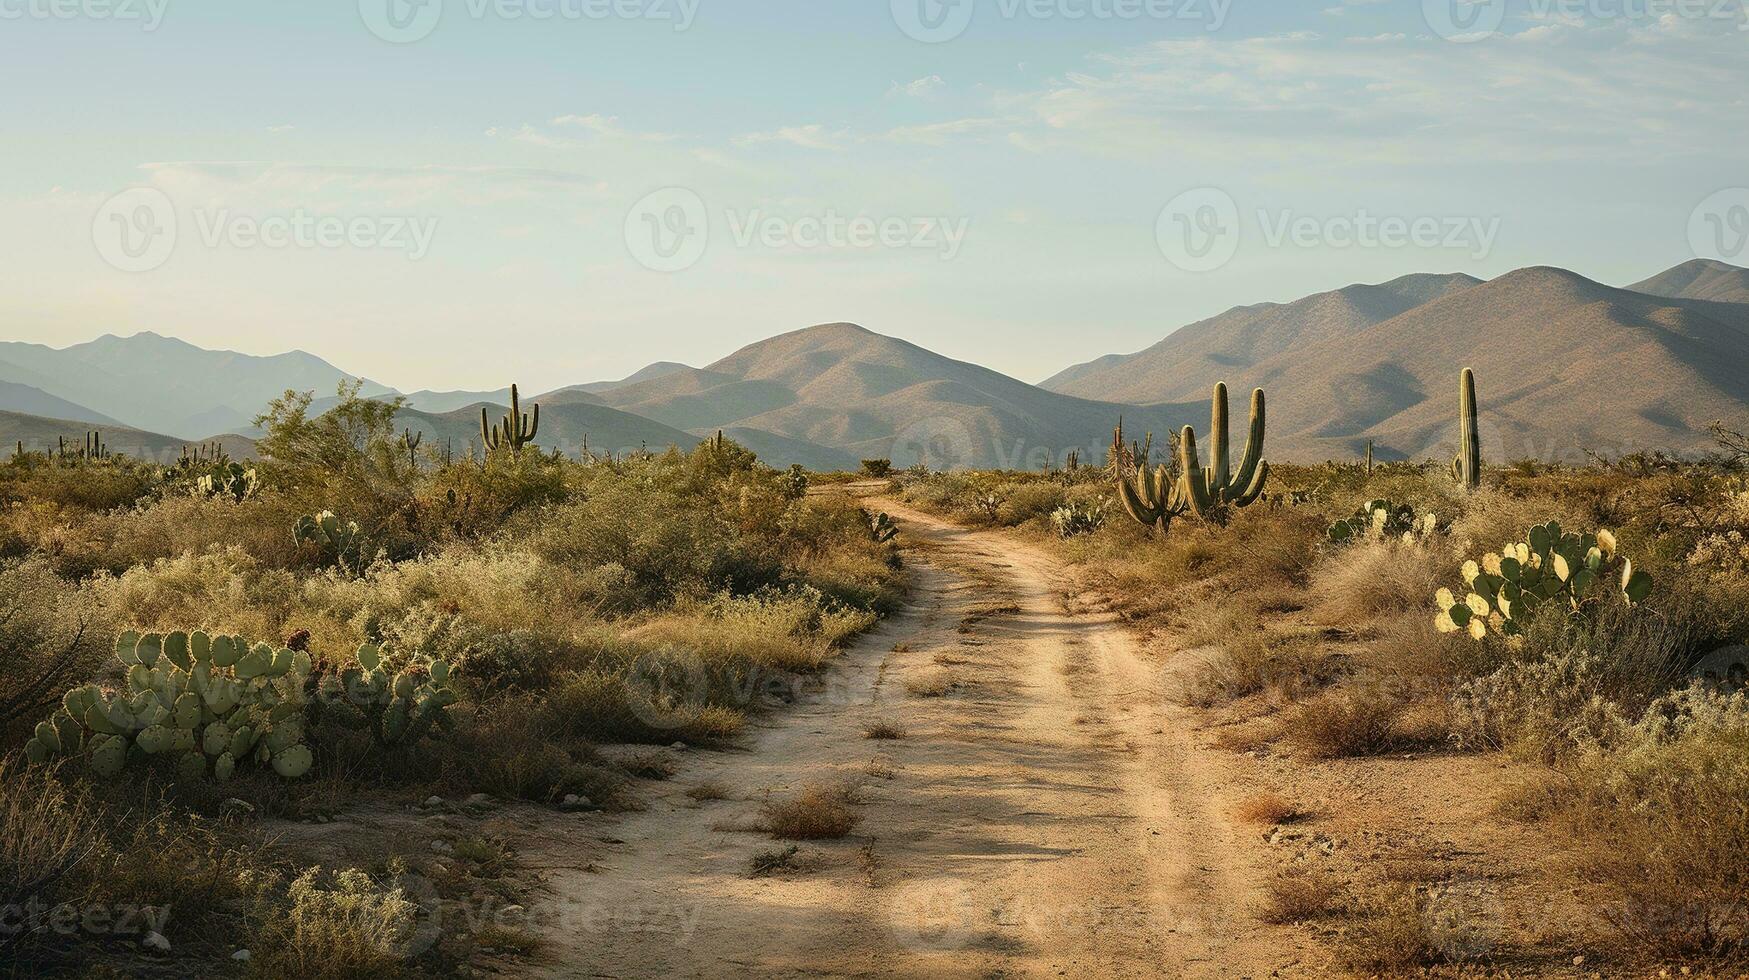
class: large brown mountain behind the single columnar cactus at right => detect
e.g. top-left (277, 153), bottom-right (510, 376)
top-left (1196, 268), bottom-right (1749, 460)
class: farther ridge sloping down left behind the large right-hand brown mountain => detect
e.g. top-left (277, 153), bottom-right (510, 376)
top-left (1041, 275), bottom-right (1481, 404)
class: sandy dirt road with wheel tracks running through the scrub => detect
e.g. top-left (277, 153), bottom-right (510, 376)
top-left (530, 501), bottom-right (1307, 977)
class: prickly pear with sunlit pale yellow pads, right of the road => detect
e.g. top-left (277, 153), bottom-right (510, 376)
top-left (1434, 522), bottom-right (1651, 641)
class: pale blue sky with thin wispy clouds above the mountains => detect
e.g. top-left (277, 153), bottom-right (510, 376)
top-left (0, 0), bottom-right (1749, 390)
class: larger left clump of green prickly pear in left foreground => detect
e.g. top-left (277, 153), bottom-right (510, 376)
top-left (24, 630), bottom-right (311, 782)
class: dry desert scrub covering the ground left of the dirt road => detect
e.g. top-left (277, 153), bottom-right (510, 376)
top-left (0, 389), bottom-right (902, 977)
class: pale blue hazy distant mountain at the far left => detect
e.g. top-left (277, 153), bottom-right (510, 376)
top-left (0, 333), bottom-right (390, 438)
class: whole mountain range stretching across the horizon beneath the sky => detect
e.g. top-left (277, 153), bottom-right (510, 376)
top-left (0, 259), bottom-right (1749, 469)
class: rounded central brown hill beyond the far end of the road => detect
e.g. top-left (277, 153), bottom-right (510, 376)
top-left (602, 324), bottom-right (1186, 467)
